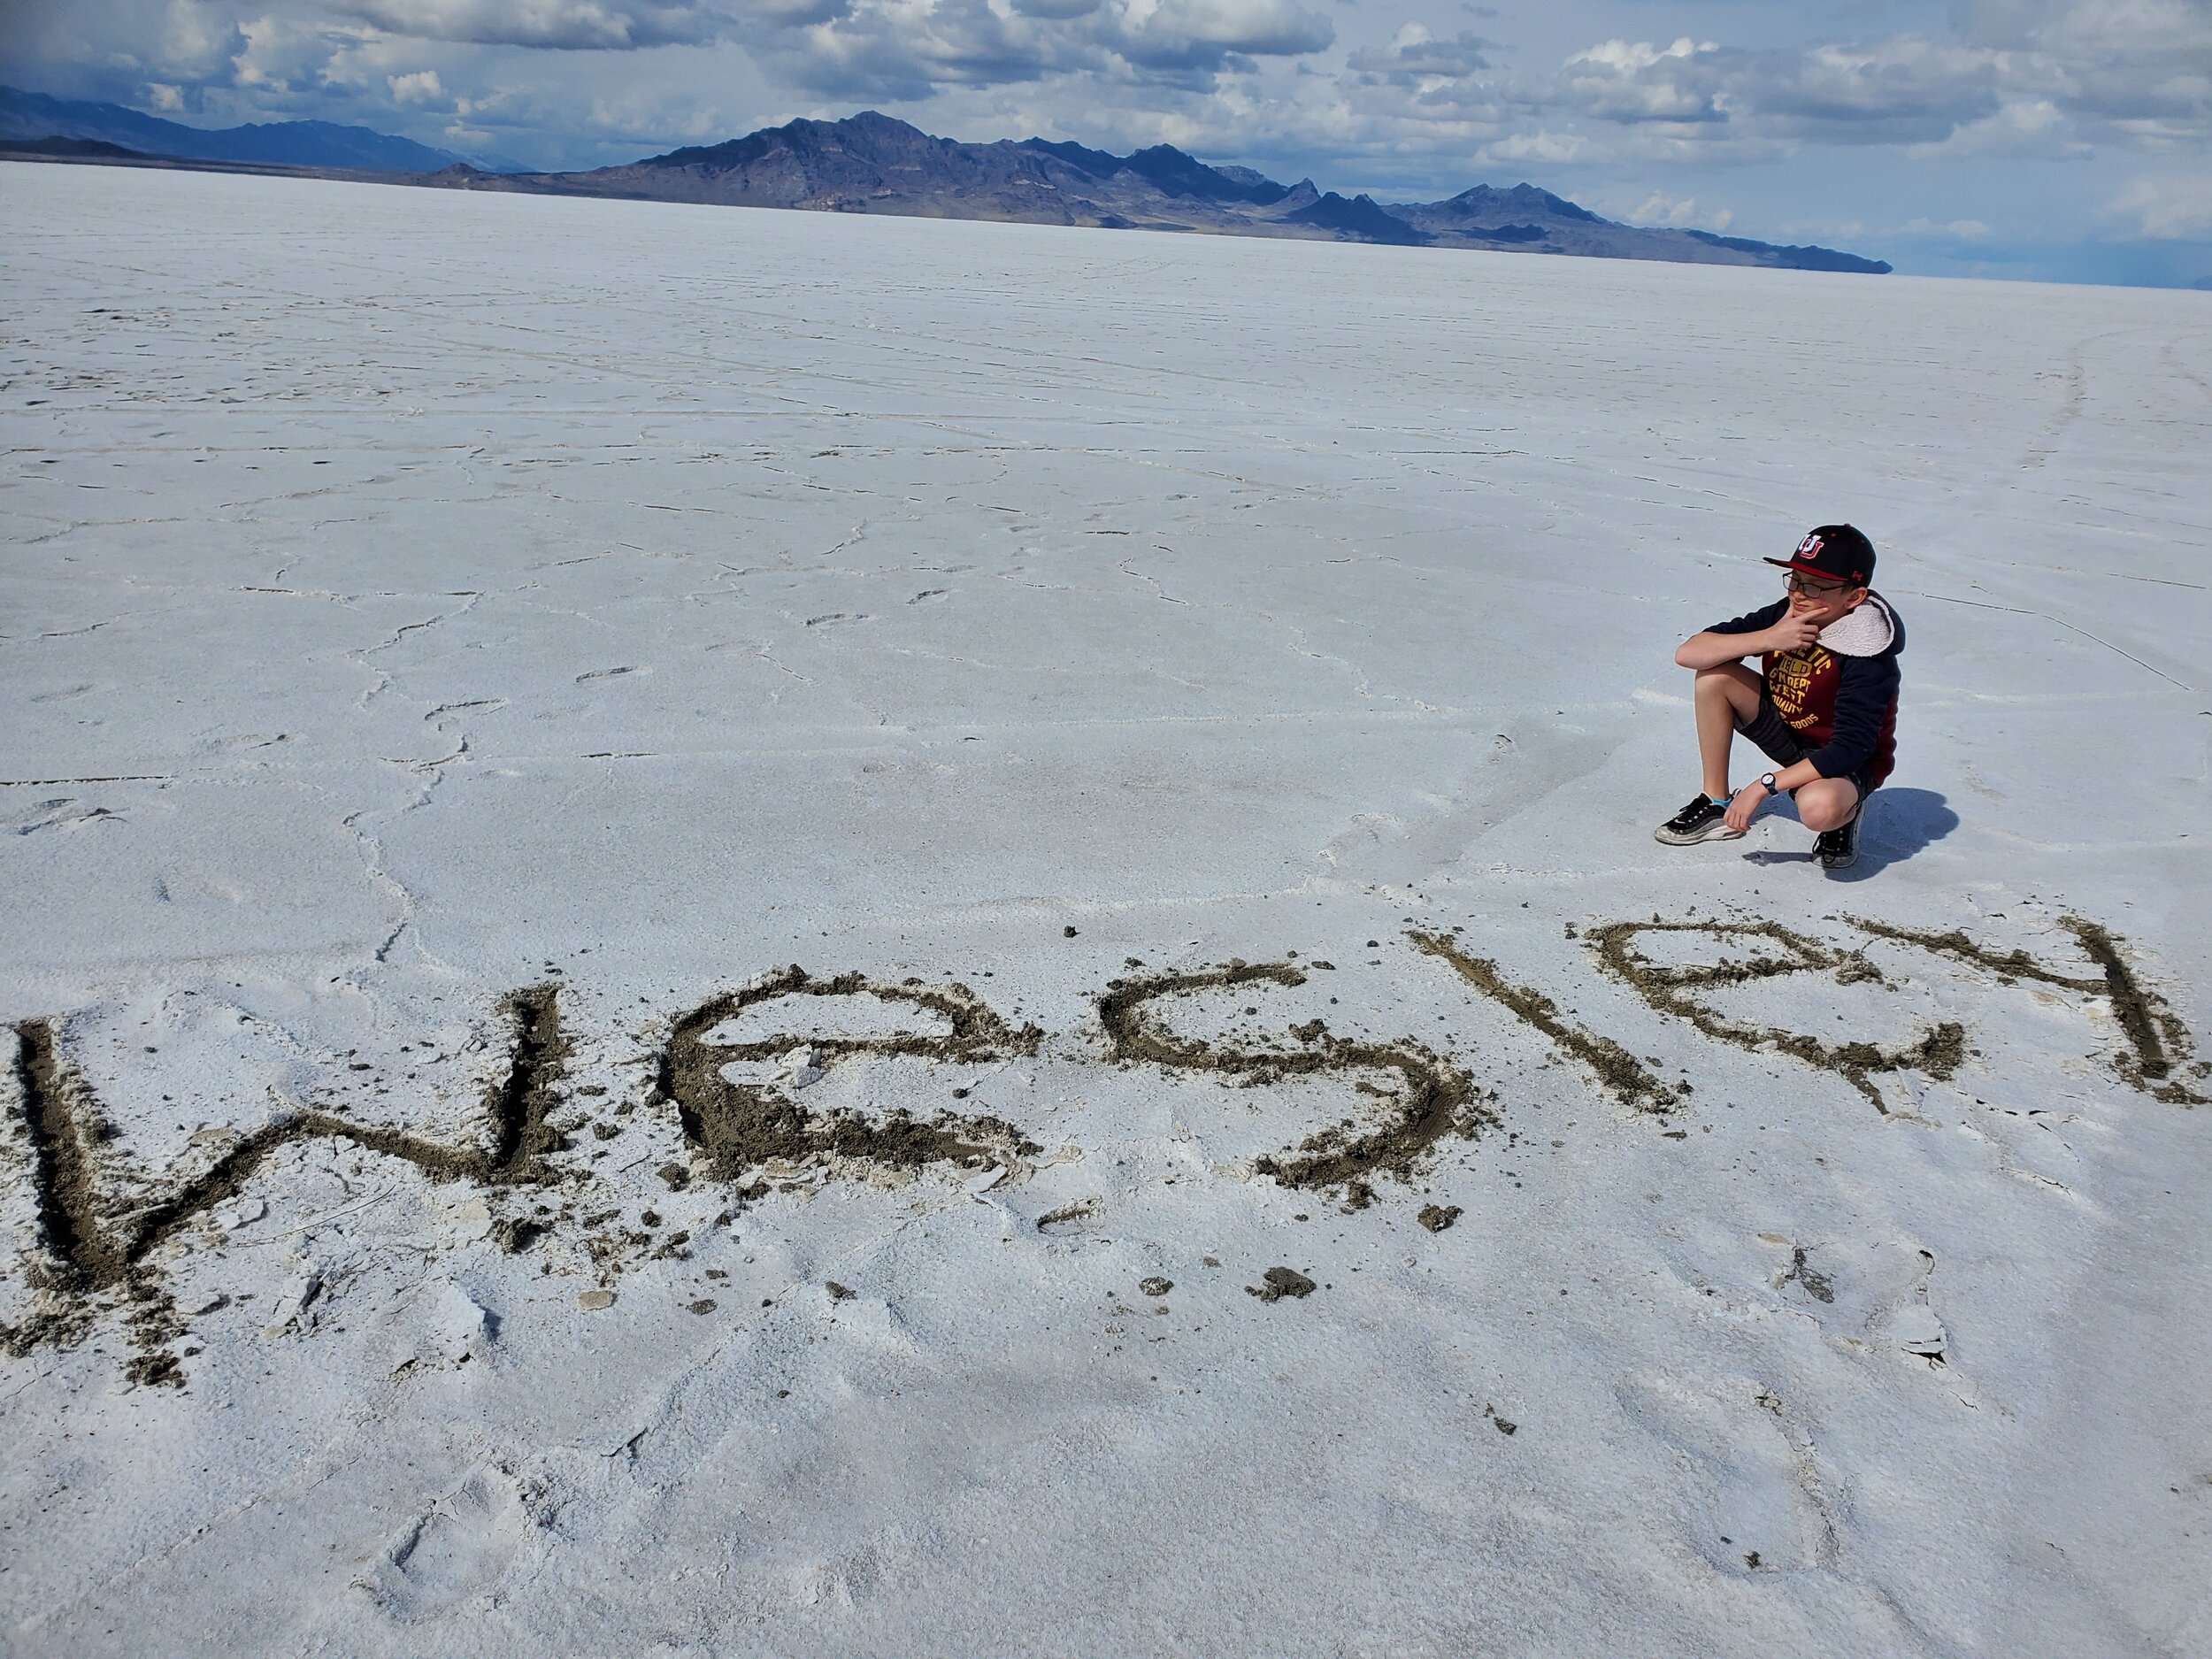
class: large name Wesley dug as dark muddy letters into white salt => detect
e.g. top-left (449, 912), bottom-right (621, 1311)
top-left (0, 916), bottom-right (2212, 1383)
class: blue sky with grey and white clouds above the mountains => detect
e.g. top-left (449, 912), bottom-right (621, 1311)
top-left (0, 0), bottom-right (2212, 283)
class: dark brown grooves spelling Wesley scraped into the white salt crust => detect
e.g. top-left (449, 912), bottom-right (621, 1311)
top-left (0, 916), bottom-right (2208, 1383)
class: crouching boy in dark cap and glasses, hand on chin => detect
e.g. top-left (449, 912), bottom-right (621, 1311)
top-left (1653, 525), bottom-right (1905, 870)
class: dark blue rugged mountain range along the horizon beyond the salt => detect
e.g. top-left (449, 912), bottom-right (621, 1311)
top-left (0, 88), bottom-right (1889, 274)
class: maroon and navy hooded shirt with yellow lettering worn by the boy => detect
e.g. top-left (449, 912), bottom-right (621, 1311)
top-left (1710, 593), bottom-right (1905, 786)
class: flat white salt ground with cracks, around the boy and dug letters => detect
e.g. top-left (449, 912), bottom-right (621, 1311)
top-left (0, 166), bottom-right (2212, 1657)
